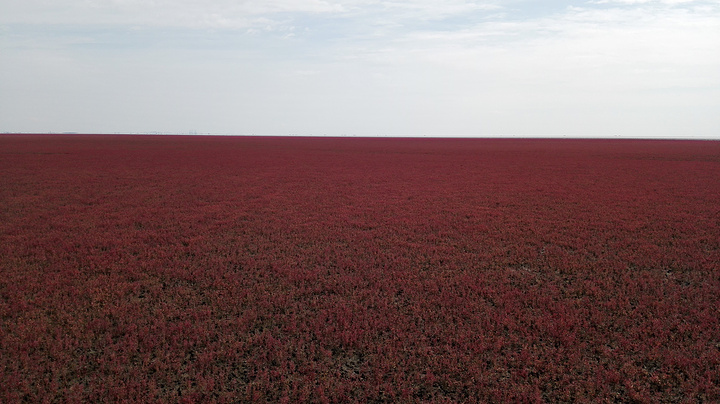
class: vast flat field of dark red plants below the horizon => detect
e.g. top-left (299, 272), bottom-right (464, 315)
top-left (0, 135), bottom-right (720, 403)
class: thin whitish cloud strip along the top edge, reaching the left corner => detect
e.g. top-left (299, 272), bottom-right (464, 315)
top-left (0, 0), bottom-right (497, 28)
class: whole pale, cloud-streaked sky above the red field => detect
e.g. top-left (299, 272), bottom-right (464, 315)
top-left (0, 0), bottom-right (720, 138)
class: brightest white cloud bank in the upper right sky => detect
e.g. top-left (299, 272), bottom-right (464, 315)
top-left (352, 2), bottom-right (720, 80)
